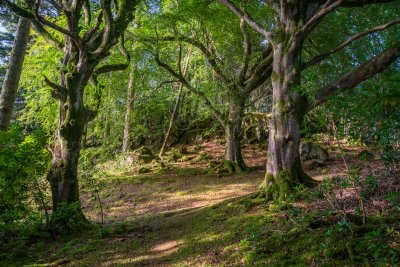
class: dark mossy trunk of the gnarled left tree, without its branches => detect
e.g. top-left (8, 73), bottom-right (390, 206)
top-left (47, 48), bottom-right (96, 224)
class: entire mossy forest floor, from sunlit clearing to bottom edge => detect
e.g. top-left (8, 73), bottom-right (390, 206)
top-left (0, 141), bottom-right (400, 266)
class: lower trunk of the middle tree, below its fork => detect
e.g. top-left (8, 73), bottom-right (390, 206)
top-left (224, 97), bottom-right (247, 172)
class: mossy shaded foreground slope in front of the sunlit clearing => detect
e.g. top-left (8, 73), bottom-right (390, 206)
top-left (3, 191), bottom-right (400, 266)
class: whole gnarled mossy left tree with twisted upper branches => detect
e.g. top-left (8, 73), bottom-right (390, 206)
top-left (1, 0), bottom-right (139, 223)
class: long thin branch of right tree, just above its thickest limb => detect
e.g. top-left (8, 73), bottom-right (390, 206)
top-left (303, 18), bottom-right (400, 69)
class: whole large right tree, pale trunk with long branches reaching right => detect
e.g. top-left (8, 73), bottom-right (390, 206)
top-left (219, 0), bottom-right (400, 199)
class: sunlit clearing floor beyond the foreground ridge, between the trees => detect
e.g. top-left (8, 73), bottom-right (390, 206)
top-left (82, 141), bottom-right (265, 223)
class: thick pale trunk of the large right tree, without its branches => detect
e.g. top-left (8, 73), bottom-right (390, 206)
top-left (262, 36), bottom-right (313, 200)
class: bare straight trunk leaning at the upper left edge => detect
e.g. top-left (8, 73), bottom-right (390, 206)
top-left (0, 17), bottom-right (31, 131)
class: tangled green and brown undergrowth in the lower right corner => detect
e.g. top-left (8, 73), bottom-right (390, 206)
top-left (242, 171), bottom-right (400, 266)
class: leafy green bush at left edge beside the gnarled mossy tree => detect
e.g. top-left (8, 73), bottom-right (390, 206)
top-left (0, 125), bottom-right (50, 255)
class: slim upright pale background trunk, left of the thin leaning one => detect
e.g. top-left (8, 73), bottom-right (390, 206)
top-left (122, 64), bottom-right (136, 152)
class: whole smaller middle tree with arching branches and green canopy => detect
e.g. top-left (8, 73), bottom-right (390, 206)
top-left (143, 2), bottom-right (272, 172)
